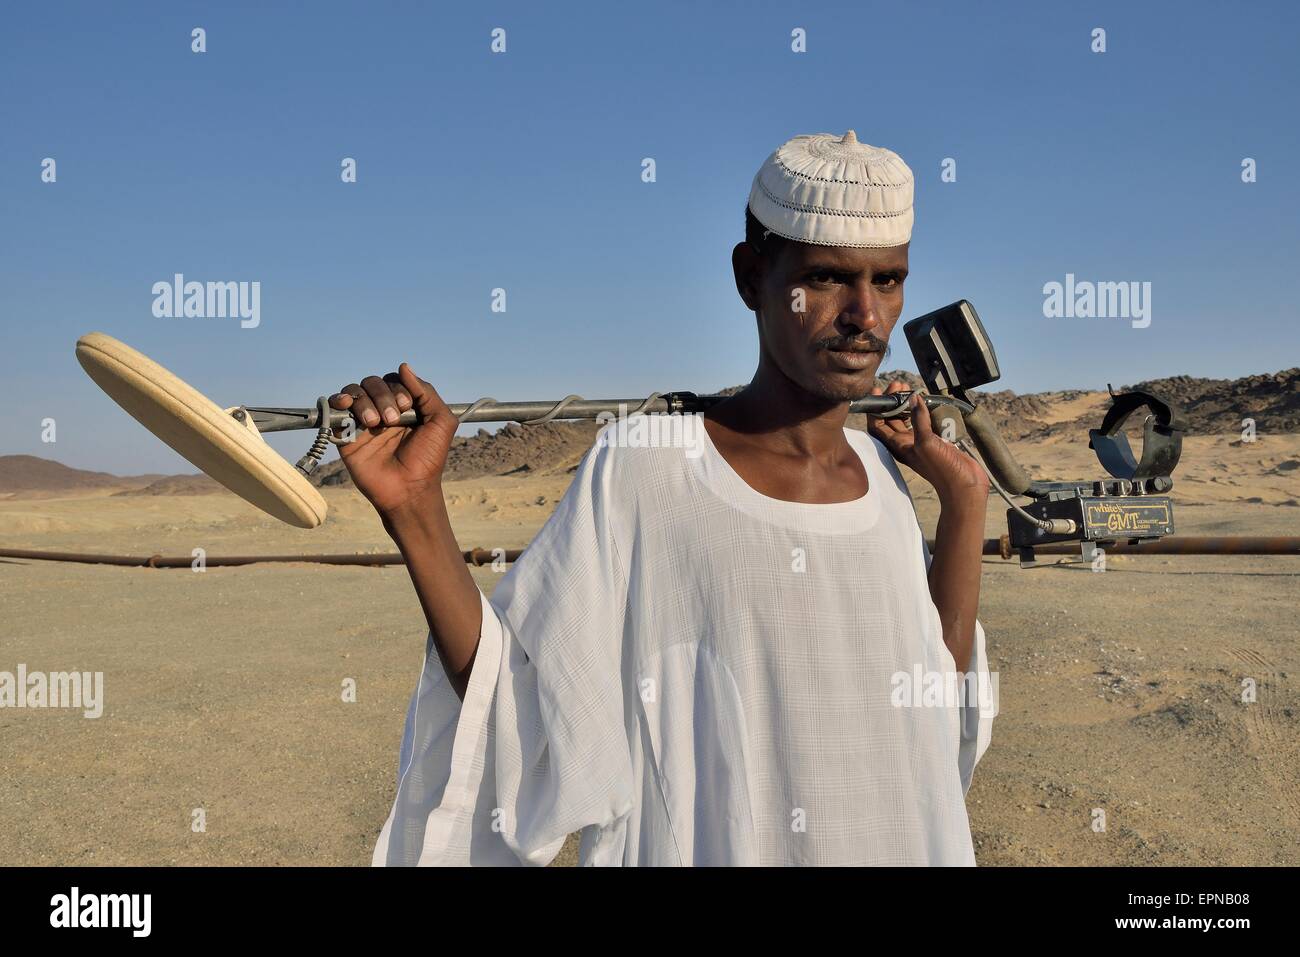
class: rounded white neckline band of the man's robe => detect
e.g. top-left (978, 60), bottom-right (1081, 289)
top-left (694, 416), bottom-right (889, 534)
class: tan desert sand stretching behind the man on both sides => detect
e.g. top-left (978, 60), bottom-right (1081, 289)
top-left (0, 410), bottom-right (1300, 865)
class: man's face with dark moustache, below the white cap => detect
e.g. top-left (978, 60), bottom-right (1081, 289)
top-left (732, 241), bottom-right (907, 402)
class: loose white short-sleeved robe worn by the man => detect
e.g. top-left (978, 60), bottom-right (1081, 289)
top-left (374, 423), bottom-right (996, 865)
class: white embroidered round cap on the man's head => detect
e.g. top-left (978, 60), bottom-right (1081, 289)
top-left (749, 130), bottom-right (913, 246)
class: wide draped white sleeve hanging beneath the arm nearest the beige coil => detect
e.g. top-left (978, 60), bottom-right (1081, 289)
top-left (373, 433), bottom-right (633, 866)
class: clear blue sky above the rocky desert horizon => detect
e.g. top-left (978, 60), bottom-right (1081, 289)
top-left (0, 1), bottom-right (1300, 472)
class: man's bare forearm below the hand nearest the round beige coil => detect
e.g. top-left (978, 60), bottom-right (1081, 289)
top-left (382, 492), bottom-right (482, 700)
